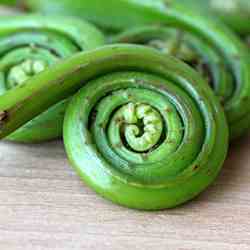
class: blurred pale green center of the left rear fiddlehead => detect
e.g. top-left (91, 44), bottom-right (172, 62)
top-left (7, 59), bottom-right (47, 89)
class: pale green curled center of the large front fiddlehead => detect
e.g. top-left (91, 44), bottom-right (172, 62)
top-left (119, 103), bottom-right (163, 152)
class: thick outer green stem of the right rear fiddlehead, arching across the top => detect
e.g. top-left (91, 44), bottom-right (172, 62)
top-left (23, 0), bottom-right (250, 139)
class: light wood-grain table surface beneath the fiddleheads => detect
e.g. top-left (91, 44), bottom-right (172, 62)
top-left (0, 5), bottom-right (250, 250)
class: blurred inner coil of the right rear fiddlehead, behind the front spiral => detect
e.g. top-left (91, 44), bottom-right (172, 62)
top-left (110, 25), bottom-right (234, 104)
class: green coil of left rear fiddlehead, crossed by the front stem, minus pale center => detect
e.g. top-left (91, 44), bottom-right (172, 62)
top-left (0, 15), bottom-right (105, 142)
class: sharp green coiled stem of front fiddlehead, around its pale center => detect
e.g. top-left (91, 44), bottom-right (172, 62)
top-left (0, 45), bottom-right (228, 210)
